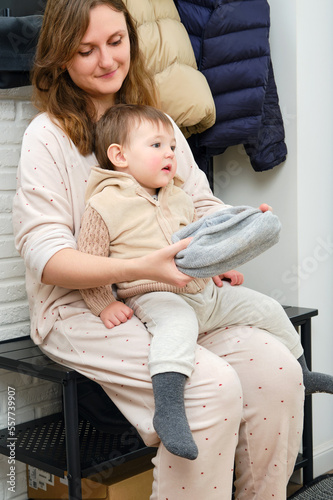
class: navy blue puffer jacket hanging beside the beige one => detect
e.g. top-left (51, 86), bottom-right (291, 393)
top-left (175, 0), bottom-right (287, 171)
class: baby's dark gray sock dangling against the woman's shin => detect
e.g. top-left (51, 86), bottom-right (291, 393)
top-left (152, 372), bottom-right (198, 460)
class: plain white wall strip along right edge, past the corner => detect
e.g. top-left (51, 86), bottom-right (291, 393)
top-left (296, 0), bottom-right (333, 474)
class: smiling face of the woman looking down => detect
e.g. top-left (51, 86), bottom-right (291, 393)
top-left (66, 5), bottom-right (130, 114)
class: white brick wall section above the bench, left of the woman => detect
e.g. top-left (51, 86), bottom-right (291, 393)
top-left (0, 87), bottom-right (35, 340)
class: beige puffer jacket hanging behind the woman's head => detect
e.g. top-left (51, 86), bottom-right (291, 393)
top-left (124, 0), bottom-right (215, 137)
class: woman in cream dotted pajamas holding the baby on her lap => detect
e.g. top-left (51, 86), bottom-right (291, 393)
top-left (14, 0), bottom-right (303, 500)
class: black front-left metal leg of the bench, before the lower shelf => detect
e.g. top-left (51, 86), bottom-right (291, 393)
top-left (63, 380), bottom-right (82, 500)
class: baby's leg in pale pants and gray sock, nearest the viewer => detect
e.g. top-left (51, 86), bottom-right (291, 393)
top-left (127, 292), bottom-right (198, 460)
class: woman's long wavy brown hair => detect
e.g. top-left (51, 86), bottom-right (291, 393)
top-left (32, 0), bottom-right (158, 155)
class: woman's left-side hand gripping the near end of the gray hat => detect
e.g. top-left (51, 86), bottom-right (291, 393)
top-left (134, 238), bottom-right (193, 287)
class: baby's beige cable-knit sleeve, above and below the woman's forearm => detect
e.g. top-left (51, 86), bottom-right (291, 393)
top-left (77, 207), bottom-right (116, 316)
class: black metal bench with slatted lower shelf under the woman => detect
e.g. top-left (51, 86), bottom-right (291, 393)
top-left (0, 306), bottom-right (318, 500)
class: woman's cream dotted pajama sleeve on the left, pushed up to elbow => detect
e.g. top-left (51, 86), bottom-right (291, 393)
top-left (13, 114), bottom-right (82, 283)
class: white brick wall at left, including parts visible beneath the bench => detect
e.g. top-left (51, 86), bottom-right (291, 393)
top-left (0, 87), bottom-right (61, 500)
